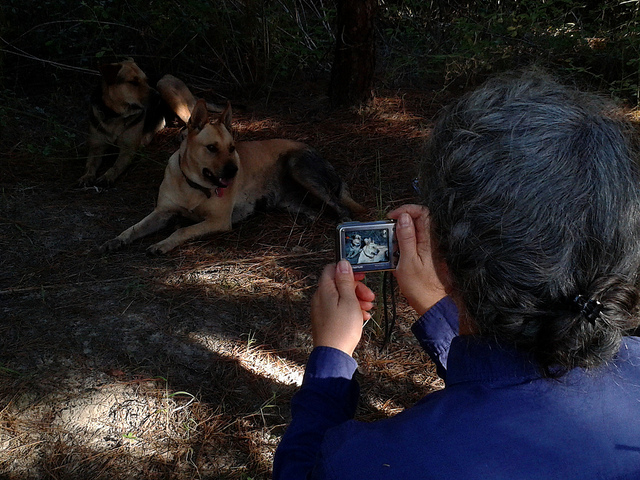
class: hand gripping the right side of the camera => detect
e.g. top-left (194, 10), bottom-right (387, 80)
top-left (388, 205), bottom-right (448, 315)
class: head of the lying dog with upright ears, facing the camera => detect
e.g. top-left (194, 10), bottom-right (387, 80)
top-left (181, 99), bottom-right (240, 196)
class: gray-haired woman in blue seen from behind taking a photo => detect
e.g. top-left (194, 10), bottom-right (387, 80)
top-left (274, 71), bottom-right (640, 480)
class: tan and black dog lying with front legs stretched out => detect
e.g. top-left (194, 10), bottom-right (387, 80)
top-left (100, 100), bottom-right (364, 254)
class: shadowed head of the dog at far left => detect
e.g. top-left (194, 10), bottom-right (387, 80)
top-left (99, 59), bottom-right (150, 116)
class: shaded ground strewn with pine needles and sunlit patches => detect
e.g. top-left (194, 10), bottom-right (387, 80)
top-left (0, 72), bottom-right (450, 480)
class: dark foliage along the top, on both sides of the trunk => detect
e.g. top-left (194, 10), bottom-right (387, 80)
top-left (0, 0), bottom-right (640, 98)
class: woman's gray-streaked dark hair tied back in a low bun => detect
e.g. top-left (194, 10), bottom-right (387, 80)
top-left (420, 69), bottom-right (640, 375)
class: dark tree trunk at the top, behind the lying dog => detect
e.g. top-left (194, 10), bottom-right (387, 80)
top-left (329, 0), bottom-right (378, 107)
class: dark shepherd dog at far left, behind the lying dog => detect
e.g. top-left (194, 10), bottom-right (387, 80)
top-left (78, 58), bottom-right (202, 187)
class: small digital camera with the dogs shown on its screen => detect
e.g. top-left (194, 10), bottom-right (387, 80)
top-left (336, 220), bottom-right (400, 272)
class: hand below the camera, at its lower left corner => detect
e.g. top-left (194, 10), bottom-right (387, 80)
top-left (311, 260), bottom-right (375, 355)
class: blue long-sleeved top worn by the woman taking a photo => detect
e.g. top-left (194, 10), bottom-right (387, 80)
top-left (273, 298), bottom-right (640, 480)
